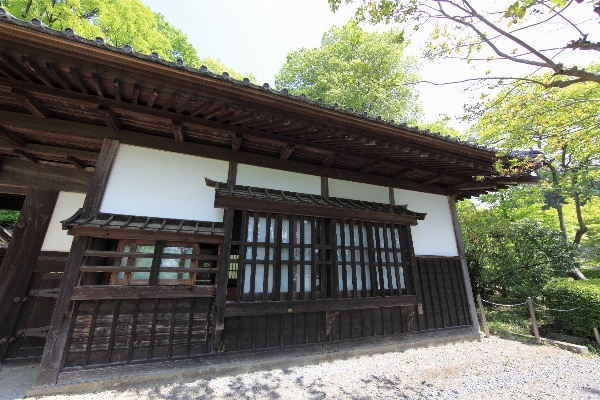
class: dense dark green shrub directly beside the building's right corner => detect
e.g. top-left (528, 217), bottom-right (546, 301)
top-left (458, 201), bottom-right (577, 297)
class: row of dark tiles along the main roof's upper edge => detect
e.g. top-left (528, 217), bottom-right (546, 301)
top-left (0, 8), bottom-right (502, 156)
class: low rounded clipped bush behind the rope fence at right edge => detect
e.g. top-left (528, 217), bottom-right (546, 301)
top-left (543, 279), bottom-right (600, 339)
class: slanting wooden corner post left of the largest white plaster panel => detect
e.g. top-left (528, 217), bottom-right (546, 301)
top-left (34, 139), bottom-right (119, 387)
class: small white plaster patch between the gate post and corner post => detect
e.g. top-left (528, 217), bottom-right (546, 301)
top-left (42, 192), bottom-right (85, 252)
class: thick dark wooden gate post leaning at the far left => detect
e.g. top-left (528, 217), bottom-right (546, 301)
top-left (0, 189), bottom-right (58, 362)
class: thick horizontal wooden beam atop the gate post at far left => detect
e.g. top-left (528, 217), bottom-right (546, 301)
top-left (0, 157), bottom-right (92, 193)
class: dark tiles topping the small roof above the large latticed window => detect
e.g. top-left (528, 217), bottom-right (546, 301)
top-left (205, 179), bottom-right (427, 220)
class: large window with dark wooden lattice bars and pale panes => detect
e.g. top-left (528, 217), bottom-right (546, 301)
top-left (230, 211), bottom-right (410, 301)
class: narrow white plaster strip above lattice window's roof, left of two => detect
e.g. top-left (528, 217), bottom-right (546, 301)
top-left (236, 164), bottom-right (321, 195)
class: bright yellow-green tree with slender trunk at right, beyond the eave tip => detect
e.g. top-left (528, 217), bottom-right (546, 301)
top-left (469, 66), bottom-right (600, 266)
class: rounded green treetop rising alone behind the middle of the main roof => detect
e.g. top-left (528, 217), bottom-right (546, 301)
top-left (275, 23), bottom-right (421, 122)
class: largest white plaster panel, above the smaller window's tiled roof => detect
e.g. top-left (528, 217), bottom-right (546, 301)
top-left (100, 145), bottom-right (229, 222)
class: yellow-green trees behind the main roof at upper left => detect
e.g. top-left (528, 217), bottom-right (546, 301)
top-left (0, 0), bottom-right (256, 82)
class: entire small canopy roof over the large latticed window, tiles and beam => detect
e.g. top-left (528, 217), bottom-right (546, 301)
top-left (205, 179), bottom-right (427, 225)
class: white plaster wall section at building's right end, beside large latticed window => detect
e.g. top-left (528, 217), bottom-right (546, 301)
top-left (394, 189), bottom-right (458, 257)
